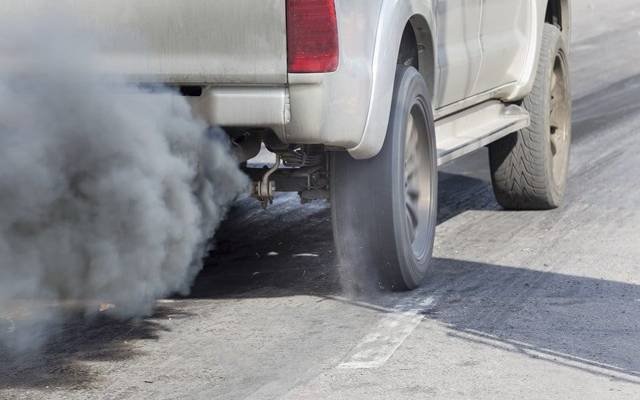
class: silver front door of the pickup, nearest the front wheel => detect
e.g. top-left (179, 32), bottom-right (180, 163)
top-left (476, 0), bottom-right (534, 93)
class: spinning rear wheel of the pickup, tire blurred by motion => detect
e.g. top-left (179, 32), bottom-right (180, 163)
top-left (331, 66), bottom-right (438, 290)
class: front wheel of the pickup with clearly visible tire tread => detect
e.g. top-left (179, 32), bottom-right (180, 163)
top-left (489, 24), bottom-right (571, 210)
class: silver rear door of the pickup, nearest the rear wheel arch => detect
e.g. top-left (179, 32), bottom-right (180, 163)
top-left (434, 0), bottom-right (482, 108)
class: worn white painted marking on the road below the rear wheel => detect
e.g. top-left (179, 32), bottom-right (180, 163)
top-left (338, 297), bottom-right (435, 369)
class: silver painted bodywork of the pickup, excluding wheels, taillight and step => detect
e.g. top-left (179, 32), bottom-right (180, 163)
top-left (0, 0), bottom-right (570, 158)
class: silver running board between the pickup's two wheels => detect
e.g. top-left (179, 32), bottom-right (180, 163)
top-left (436, 101), bottom-right (530, 166)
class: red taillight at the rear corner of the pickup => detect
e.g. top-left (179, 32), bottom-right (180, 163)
top-left (287, 0), bottom-right (338, 73)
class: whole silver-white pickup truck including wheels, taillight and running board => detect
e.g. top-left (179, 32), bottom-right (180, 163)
top-left (0, 0), bottom-right (571, 290)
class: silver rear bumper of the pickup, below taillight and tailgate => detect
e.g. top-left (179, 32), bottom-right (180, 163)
top-left (189, 65), bottom-right (371, 153)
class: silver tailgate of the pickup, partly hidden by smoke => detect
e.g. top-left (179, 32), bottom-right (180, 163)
top-left (0, 0), bottom-right (287, 85)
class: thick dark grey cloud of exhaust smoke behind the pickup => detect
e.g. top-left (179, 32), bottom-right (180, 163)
top-left (0, 15), bottom-right (248, 350)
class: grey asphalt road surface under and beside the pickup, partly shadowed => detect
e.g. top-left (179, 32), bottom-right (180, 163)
top-left (0, 0), bottom-right (640, 400)
